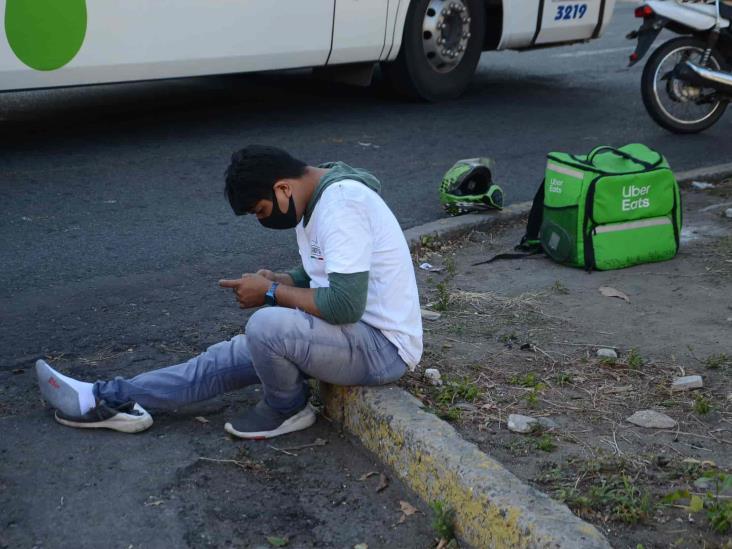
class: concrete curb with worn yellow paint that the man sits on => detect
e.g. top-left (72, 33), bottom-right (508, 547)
top-left (321, 163), bottom-right (732, 548)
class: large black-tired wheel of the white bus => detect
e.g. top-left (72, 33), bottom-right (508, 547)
top-left (383, 0), bottom-right (486, 101)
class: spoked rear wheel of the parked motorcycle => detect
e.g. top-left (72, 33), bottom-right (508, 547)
top-left (641, 36), bottom-right (727, 133)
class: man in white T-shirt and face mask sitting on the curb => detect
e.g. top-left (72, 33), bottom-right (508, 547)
top-left (36, 145), bottom-right (422, 438)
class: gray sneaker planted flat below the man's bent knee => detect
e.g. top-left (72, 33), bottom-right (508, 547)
top-left (224, 400), bottom-right (315, 440)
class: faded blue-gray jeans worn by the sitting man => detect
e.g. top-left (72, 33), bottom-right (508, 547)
top-left (94, 307), bottom-right (406, 413)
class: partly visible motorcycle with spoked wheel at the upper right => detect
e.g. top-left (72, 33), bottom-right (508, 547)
top-left (627, 0), bottom-right (732, 133)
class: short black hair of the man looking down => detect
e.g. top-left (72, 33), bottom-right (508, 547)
top-left (224, 145), bottom-right (308, 215)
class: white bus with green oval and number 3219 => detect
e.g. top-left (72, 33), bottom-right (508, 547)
top-left (0, 0), bottom-right (615, 101)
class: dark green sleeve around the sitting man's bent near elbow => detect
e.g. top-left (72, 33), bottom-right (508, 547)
top-left (315, 271), bottom-right (369, 324)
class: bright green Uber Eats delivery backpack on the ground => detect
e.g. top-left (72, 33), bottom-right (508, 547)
top-left (518, 144), bottom-right (682, 271)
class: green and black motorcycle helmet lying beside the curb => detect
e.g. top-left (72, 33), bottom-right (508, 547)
top-left (440, 158), bottom-right (503, 215)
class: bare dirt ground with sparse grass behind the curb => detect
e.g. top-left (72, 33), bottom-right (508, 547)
top-left (403, 180), bottom-right (732, 549)
